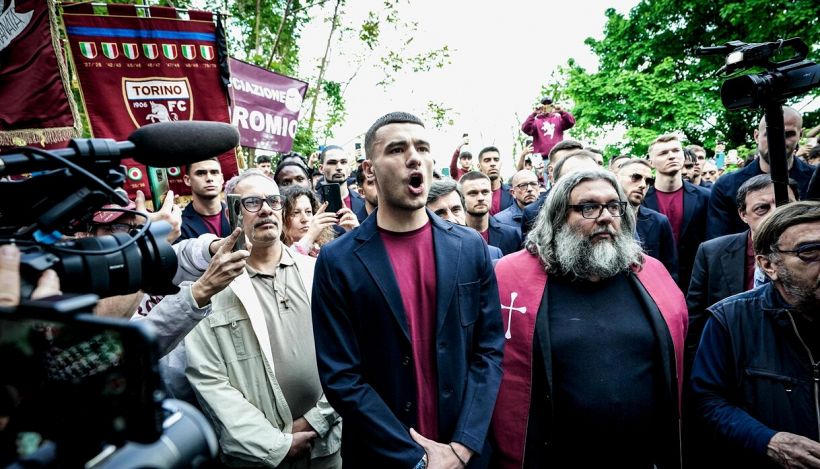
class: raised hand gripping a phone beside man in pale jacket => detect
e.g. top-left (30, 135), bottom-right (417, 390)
top-left (191, 228), bottom-right (250, 308)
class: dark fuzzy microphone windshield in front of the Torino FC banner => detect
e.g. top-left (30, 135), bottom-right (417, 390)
top-left (128, 121), bottom-right (239, 168)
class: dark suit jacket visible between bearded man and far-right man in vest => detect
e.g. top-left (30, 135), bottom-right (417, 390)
top-left (686, 231), bottom-right (749, 366)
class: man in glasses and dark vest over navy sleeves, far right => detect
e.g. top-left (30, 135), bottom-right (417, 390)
top-left (692, 201), bottom-right (820, 468)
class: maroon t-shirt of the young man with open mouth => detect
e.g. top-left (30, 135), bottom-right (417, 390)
top-left (379, 221), bottom-right (438, 441)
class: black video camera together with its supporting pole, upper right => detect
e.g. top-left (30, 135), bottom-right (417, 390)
top-left (695, 37), bottom-right (820, 206)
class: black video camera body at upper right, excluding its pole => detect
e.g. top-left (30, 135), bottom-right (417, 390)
top-left (695, 37), bottom-right (820, 111)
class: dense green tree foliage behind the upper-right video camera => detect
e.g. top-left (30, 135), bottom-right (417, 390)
top-left (551, 0), bottom-right (820, 154)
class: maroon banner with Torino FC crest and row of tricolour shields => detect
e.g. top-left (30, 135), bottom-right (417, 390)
top-left (63, 4), bottom-right (238, 196)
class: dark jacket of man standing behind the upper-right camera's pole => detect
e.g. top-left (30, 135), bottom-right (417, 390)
top-left (706, 157), bottom-right (814, 239)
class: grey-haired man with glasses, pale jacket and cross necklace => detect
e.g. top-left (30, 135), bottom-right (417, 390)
top-left (185, 169), bottom-right (341, 468)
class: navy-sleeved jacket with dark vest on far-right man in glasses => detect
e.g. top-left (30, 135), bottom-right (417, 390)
top-left (692, 283), bottom-right (820, 468)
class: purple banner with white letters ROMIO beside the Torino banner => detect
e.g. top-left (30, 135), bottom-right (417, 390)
top-left (230, 58), bottom-right (307, 152)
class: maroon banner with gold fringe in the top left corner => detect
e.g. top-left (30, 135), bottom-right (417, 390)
top-left (0, 0), bottom-right (79, 146)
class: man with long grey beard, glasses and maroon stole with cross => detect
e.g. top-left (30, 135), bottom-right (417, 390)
top-left (492, 169), bottom-right (688, 468)
